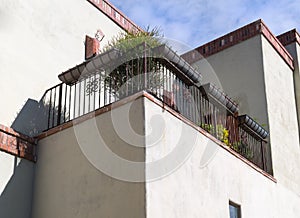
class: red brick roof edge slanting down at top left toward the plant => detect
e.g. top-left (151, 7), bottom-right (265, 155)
top-left (87, 0), bottom-right (144, 32)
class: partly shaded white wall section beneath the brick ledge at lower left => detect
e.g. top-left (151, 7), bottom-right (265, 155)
top-left (0, 151), bottom-right (34, 218)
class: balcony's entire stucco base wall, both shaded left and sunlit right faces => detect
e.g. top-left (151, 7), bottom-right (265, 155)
top-left (32, 96), bottom-right (300, 218)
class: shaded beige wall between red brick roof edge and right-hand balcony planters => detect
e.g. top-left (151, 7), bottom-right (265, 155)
top-left (193, 35), bottom-right (268, 130)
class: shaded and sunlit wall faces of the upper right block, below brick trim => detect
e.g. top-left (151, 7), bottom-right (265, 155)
top-left (191, 34), bottom-right (300, 193)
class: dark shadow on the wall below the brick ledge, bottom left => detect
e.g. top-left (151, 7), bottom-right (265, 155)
top-left (0, 157), bottom-right (34, 218)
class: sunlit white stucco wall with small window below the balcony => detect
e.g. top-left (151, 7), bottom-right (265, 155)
top-left (145, 100), bottom-right (300, 218)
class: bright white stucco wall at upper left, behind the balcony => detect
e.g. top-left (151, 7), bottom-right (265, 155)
top-left (0, 0), bottom-right (121, 126)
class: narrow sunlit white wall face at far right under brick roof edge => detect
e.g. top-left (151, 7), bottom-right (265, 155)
top-left (262, 38), bottom-right (300, 194)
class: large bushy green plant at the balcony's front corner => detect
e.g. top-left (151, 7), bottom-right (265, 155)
top-left (104, 27), bottom-right (164, 98)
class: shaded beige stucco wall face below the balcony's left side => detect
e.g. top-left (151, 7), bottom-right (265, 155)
top-left (32, 99), bottom-right (146, 218)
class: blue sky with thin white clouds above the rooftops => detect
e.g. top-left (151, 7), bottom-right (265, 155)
top-left (110, 0), bottom-right (300, 48)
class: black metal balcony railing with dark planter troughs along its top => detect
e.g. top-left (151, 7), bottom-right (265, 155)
top-left (41, 45), bottom-right (272, 174)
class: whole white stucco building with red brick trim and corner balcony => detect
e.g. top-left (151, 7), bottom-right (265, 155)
top-left (0, 0), bottom-right (300, 218)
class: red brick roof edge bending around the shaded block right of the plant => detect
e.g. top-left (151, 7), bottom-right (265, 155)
top-left (182, 19), bottom-right (294, 70)
